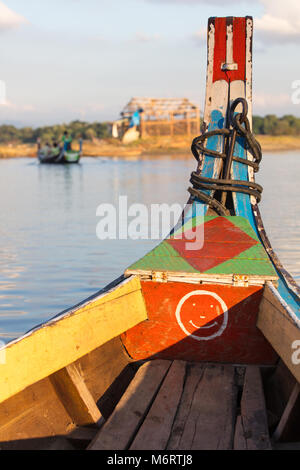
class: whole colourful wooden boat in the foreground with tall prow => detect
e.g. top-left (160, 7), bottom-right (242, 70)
top-left (0, 17), bottom-right (300, 450)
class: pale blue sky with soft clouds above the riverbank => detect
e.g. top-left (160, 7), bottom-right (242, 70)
top-left (0, 0), bottom-right (300, 126)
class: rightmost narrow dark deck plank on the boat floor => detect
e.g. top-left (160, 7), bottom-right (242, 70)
top-left (241, 366), bottom-right (272, 450)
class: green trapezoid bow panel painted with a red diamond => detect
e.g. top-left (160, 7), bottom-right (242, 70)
top-left (128, 216), bottom-right (276, 276)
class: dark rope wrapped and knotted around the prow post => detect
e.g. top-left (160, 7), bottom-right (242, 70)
top-left (188, 98), bottom-right (263, 215)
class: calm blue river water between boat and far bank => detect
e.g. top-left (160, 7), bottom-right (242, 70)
top-left (0, 152), bottom-right (300, 342)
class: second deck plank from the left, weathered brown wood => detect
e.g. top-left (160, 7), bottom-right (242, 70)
top-left (130, 361), bottom-right (186, 450)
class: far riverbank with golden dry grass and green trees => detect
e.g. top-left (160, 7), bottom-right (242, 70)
top-left (0, 115), bottom-right (300, 158)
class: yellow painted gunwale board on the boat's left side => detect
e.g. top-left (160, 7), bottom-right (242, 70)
top-left (0, 276), bottom-right (147, 403)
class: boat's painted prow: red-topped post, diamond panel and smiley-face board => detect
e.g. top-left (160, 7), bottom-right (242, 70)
top-left (119, 17), bottom-right (278, 364)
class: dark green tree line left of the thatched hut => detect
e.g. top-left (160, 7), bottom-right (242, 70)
top-left (0, 121), bottom-right (111, 143)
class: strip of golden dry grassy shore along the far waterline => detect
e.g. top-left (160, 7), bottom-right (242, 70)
top-left (0, 135), bottom-right (300, 158)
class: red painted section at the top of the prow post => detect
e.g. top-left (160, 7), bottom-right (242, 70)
top-left (213, 18), bottom-right (246, 82)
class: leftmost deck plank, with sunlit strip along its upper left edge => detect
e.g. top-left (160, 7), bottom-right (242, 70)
top-left (88, 360), bottom-right (171, 450)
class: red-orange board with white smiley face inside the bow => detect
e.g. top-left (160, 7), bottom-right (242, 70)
top-left (122, 281), bottom-right (277, 364)
